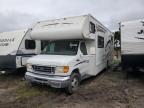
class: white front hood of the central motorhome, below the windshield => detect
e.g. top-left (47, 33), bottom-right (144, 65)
top-left (27, 55), bottom-right (76, 66)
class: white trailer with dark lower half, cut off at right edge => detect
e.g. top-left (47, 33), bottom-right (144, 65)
top-left (120, 19), bottom-right (144, 70)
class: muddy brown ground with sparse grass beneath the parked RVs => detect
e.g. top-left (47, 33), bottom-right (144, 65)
top-left (0, 71), bottom-right (144, 108)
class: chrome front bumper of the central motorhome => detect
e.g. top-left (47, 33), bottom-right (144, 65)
top-left (25, 72), bottom-right (70, 88)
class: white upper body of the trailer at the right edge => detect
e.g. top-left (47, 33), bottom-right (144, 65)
top-left (121, 19), bottom-right (144, 54)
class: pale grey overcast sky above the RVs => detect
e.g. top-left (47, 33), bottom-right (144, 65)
top-left (0, 0), bottom-right (144, 32)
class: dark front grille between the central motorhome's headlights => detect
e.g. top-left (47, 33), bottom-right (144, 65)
top-left (32, 65), bottom-right (55, 73)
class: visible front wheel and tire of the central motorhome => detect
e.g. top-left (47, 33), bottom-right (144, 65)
top-left (65, 73), bottom-right (80, 95)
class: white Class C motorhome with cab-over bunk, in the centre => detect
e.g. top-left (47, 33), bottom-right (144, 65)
top-left (25, 15), bottom-right (113, 93)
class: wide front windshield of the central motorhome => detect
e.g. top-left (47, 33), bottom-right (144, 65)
top-left (42, 40), bottom-right (79, 55)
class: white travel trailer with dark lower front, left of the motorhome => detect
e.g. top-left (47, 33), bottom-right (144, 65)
top-left (0, 29), bottom-right (41, 72)
